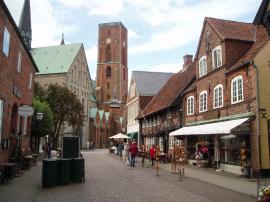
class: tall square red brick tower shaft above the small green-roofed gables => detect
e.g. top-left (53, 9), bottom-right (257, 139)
top-left (96, 22), bottom-right (128, 107)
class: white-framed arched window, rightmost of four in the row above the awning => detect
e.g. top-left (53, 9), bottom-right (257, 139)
top-left (231, 75), bottom-right (244, 104)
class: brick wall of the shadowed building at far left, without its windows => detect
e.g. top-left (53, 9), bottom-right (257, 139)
top-left (0, 3), bottom-right (35, 160)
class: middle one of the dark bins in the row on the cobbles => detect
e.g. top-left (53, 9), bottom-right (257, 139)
top-left (57, 159), bottom-right (71, 185)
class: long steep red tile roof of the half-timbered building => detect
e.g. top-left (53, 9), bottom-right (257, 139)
top-left (139, 63), bottom-right (195, 118)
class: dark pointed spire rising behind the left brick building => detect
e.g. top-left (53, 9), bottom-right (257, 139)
top-left (19, 0), bottom-right (32, 50)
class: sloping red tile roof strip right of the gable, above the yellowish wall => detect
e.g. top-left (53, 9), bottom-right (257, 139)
top-left (227, 25), bottom-right (270, 72)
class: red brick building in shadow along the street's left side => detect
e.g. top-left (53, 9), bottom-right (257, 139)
top-left (0, 0), bottom-right (38, 160)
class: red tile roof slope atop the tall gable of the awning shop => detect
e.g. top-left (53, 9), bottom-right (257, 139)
top-left (205, 17), bottom-right (255, 41)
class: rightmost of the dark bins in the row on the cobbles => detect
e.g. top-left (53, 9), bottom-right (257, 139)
top-left (71, 158), bottom-right (84, 183)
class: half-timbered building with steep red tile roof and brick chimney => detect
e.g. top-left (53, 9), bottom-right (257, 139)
top-left (139, 55), bottom-right (195, 153)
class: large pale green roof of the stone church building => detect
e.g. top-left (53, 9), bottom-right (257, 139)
top-left (32, 43), bottom-right (83, 74)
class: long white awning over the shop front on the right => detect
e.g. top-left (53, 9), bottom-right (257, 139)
top-left (170, 118), bottom-right (249, 136)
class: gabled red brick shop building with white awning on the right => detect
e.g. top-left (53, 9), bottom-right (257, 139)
top-left (170, 12), bottom-right (269, 175)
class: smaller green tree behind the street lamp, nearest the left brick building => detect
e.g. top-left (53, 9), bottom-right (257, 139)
top-left (31, 97), bottom-right (53, 153)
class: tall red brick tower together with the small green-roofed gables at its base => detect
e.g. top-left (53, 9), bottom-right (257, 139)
top-left (89, 22), bottom-right (128, 148)
